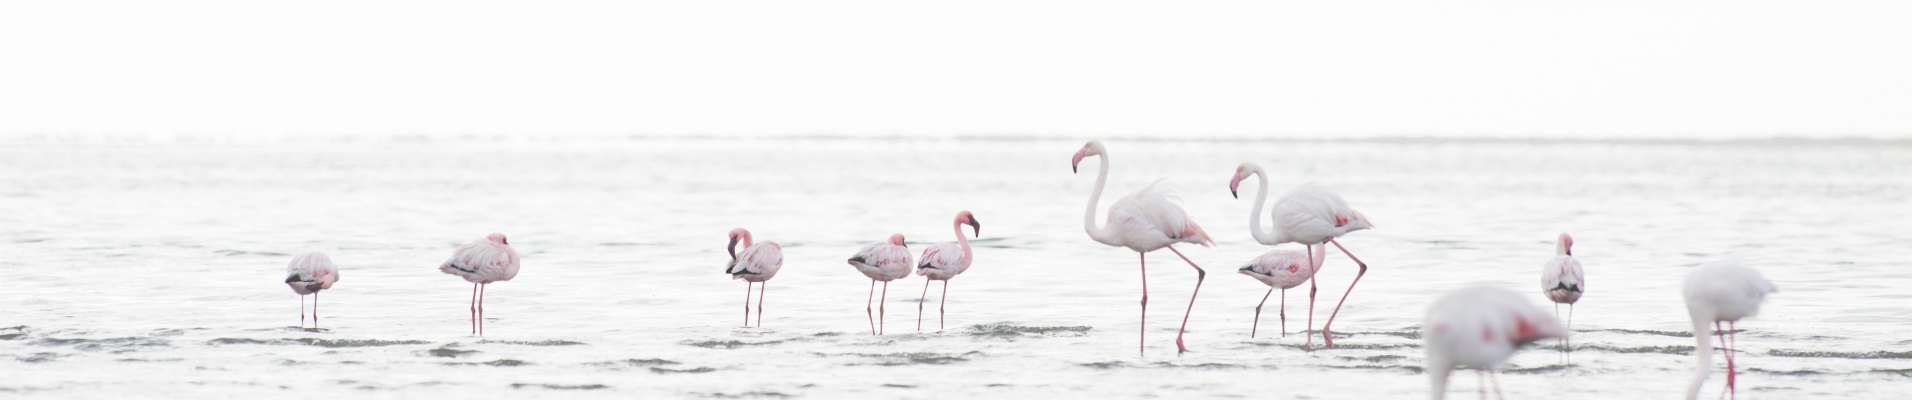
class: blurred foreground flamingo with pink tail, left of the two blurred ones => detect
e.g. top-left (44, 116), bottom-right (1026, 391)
top-left (1421, 287), bottom-right (1566, 400)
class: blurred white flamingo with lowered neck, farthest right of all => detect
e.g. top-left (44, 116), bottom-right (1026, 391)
top-left (1684, 262), bottom-right (1780, 400)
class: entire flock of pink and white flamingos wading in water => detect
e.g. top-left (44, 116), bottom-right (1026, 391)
top-left (273, 140), bottom-right (1778, 400)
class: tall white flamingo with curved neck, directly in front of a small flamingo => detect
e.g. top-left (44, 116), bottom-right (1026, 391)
top-left (1228, 163), bottom-right (1375, 348)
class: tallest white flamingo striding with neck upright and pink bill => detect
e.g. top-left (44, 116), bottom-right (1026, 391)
top-left (1069, 140), bottom-right (1214, 356)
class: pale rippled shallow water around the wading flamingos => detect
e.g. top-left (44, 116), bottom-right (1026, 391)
top-left (0, 138), bottom-right (1912, 398)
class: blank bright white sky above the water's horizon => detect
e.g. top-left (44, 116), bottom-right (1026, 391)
top-left (0, 0), bottom-right (1912, 138)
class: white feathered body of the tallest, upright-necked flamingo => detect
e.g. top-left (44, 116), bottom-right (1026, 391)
top-left (1105, 180), bottom-right (1214, 253)
